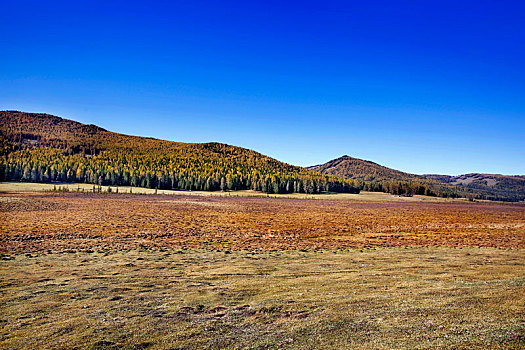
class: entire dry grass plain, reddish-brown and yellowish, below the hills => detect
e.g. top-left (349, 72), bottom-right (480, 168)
top-left (0, 188), bottom-right (525, 349)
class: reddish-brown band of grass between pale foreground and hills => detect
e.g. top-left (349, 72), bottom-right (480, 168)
top-left (0, 193), bottom-right (525, 252)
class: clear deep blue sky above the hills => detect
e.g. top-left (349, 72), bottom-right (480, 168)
top-left (0, 0), bottom-right (525, 175)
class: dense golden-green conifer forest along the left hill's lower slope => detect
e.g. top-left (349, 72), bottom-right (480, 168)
top-left (0, 148), bottom-right (361, 193)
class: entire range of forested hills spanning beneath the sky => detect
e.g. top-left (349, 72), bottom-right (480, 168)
top-left (0, 111), bottom-right (525, 201)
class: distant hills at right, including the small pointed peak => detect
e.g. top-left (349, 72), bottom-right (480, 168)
top-left (308, 155), bottom-right (525, 201)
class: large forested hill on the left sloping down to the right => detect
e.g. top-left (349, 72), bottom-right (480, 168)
top-left (0, 111), bottom-right (361, 193)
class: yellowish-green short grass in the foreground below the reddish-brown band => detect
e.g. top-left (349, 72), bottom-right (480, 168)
top-left (0, 247), bottom-right (525, 349)
